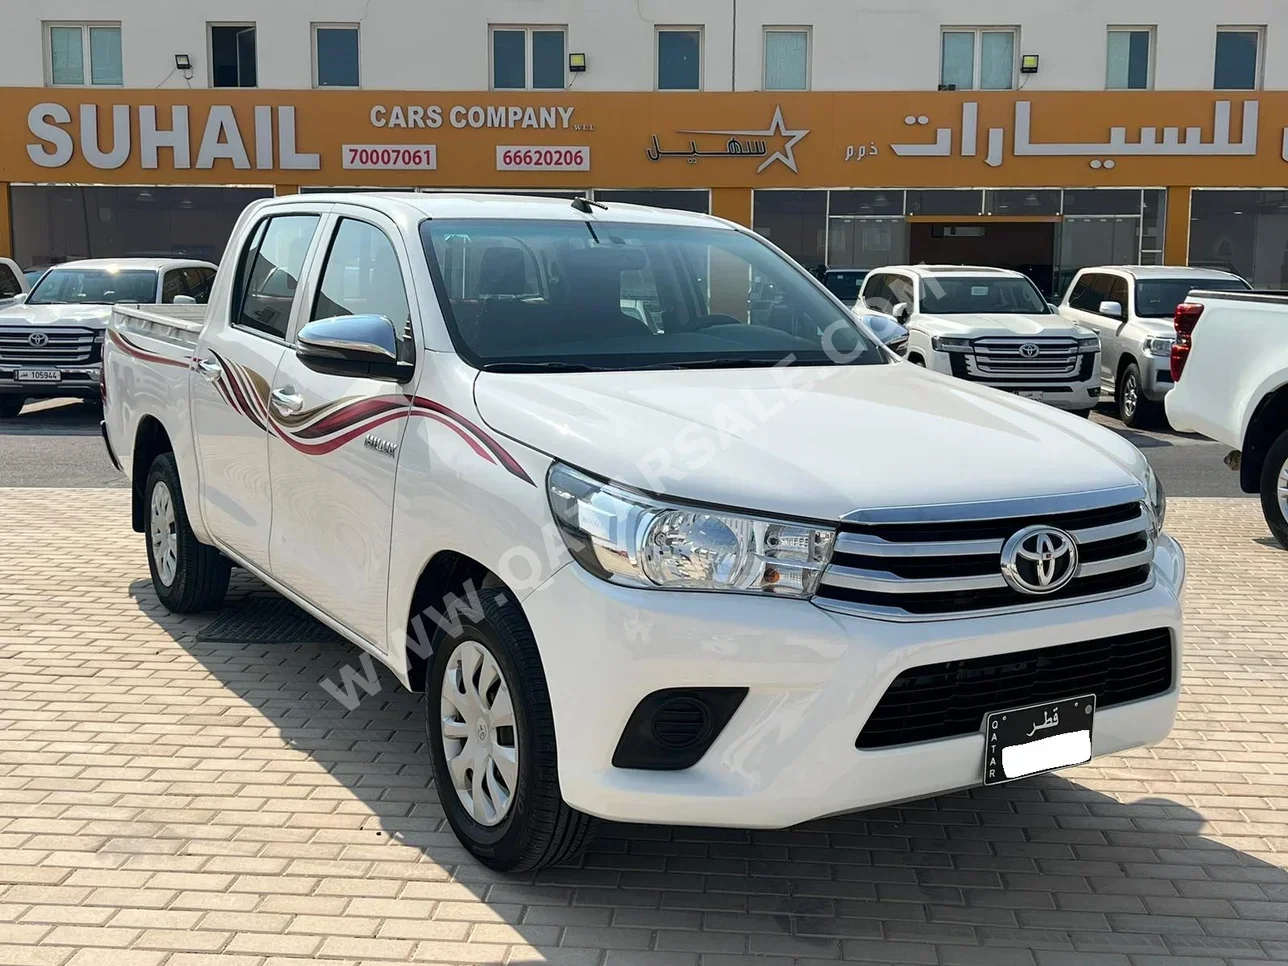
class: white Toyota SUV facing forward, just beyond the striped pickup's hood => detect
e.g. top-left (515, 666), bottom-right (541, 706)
top-left (857, 265), bottom-right (1100, 416)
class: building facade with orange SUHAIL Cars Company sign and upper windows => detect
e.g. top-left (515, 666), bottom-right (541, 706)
top-left (0, 0), bottom-right (1288, 296)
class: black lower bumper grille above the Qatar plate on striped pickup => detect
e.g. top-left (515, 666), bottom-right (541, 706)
top-left (854, 627), bottom-right (1175, 750)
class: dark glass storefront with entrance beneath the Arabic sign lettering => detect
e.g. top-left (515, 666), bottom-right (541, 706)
top-left (752, 188), bottom-right (1164, 299)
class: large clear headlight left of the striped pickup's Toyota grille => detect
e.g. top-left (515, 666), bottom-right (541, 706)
top-left (546, 464), bottom-right (836, 598)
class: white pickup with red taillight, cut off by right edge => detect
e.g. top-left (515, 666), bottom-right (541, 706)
top-left (1163, 291), bottom-right (1288, 549)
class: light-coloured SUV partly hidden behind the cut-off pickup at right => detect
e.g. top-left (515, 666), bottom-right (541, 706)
top-left (1060, 265), bottom-right (1251, 428)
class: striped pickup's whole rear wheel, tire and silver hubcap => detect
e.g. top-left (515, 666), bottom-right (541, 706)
top-left (143, 453), bottom-right (232, 614)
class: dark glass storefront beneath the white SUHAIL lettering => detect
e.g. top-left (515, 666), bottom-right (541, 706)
top-left (9, 184), bottom-right (273, 268)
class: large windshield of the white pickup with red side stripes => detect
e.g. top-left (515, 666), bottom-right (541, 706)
top-left (421, 220), bottom-right (886, 371)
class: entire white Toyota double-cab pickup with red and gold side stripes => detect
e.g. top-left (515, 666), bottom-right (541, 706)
top-left (104, 194), bottom-right (1185, 869)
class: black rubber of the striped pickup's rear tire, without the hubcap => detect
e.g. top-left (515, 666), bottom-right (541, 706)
top-left (143, 453), bottom-right (232, 614)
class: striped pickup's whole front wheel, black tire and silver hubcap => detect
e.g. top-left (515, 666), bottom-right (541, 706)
top-left (425, 590), bottom-right (592, 872)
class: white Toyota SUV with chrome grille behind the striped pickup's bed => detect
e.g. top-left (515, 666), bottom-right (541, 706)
top-left (0, 259), bottom-right (215, 419)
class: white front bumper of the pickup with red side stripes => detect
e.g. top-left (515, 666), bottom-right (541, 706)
top-left (524, 536), bottom-right (1185, 828)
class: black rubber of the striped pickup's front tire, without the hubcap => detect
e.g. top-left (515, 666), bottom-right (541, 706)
top-left (424, 590), bottom-right (595, 872)
